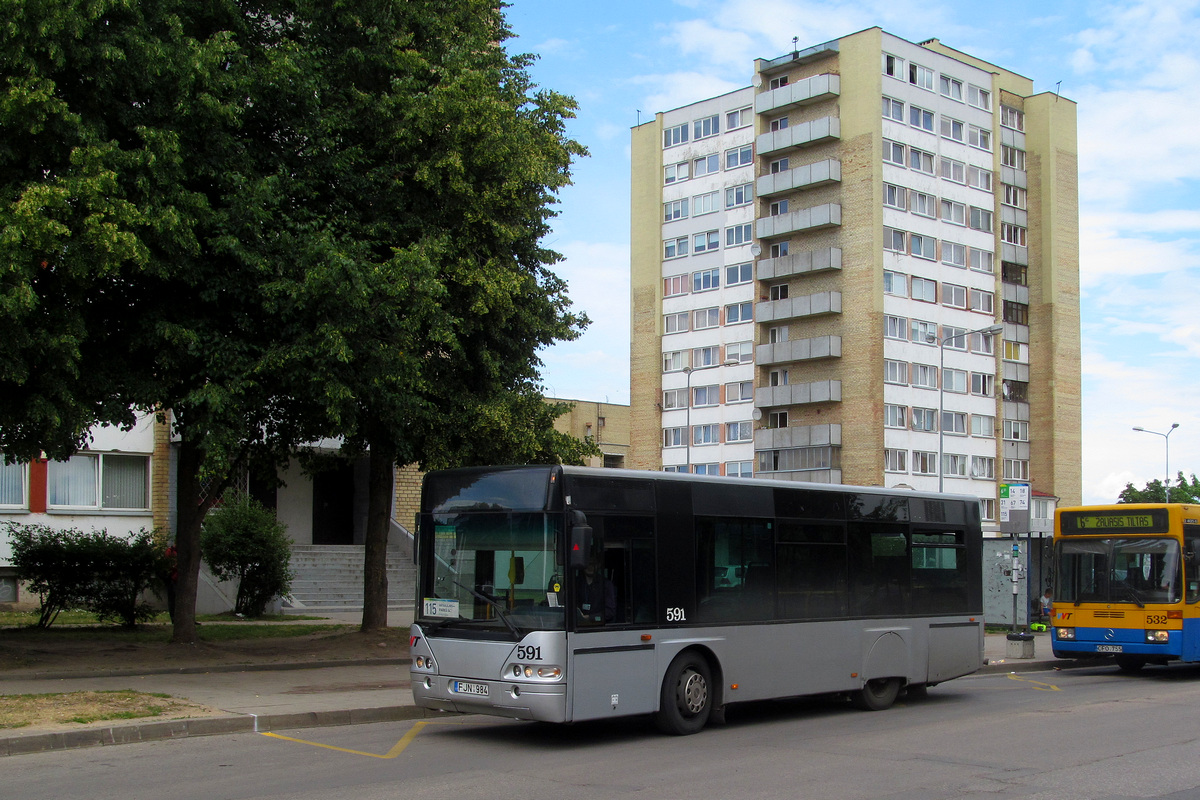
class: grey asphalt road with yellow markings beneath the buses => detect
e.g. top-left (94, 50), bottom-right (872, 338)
top-left (9, 666), bottom-right (1200, 800)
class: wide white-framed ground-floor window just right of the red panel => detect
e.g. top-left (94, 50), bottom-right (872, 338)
top-left (46, 453), bottom-right (150, 511)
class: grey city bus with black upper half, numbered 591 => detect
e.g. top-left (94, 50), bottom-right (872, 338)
top-left (410, 465), bottom-right (983, 734)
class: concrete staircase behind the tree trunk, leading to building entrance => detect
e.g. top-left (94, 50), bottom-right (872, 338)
top-left (283, 545), bottom-right (416, 614)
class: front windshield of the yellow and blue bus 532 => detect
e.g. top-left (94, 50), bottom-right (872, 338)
top-left (1056, 537), bottom-right (1182, 606)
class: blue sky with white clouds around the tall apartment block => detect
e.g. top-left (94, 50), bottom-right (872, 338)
top-left (508, 0), bottom-right (1200, 503)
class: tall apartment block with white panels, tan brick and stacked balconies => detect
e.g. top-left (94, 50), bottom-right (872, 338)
top-left (629, 28), bottom-right (1081, 527)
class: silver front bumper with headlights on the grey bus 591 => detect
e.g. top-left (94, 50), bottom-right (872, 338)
top-left (412, 674), bottom-right (566, 722)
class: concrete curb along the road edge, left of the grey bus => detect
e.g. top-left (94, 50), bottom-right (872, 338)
top-left (0, 705), bottom-right (442, 758)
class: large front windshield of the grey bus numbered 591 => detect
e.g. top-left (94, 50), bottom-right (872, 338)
top-left (420, 511), bottom-right (565, 636)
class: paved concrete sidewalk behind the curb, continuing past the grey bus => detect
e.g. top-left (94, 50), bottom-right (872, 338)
top-left (0, 619), bottom-right (1096, 756)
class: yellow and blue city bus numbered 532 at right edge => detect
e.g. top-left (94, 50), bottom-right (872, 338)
top-left (1051, 503), bottom-right (1200, 672)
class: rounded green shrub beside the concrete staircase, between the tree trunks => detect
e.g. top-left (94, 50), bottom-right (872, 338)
top-left (200, 495), bottom-right (292, 616)
